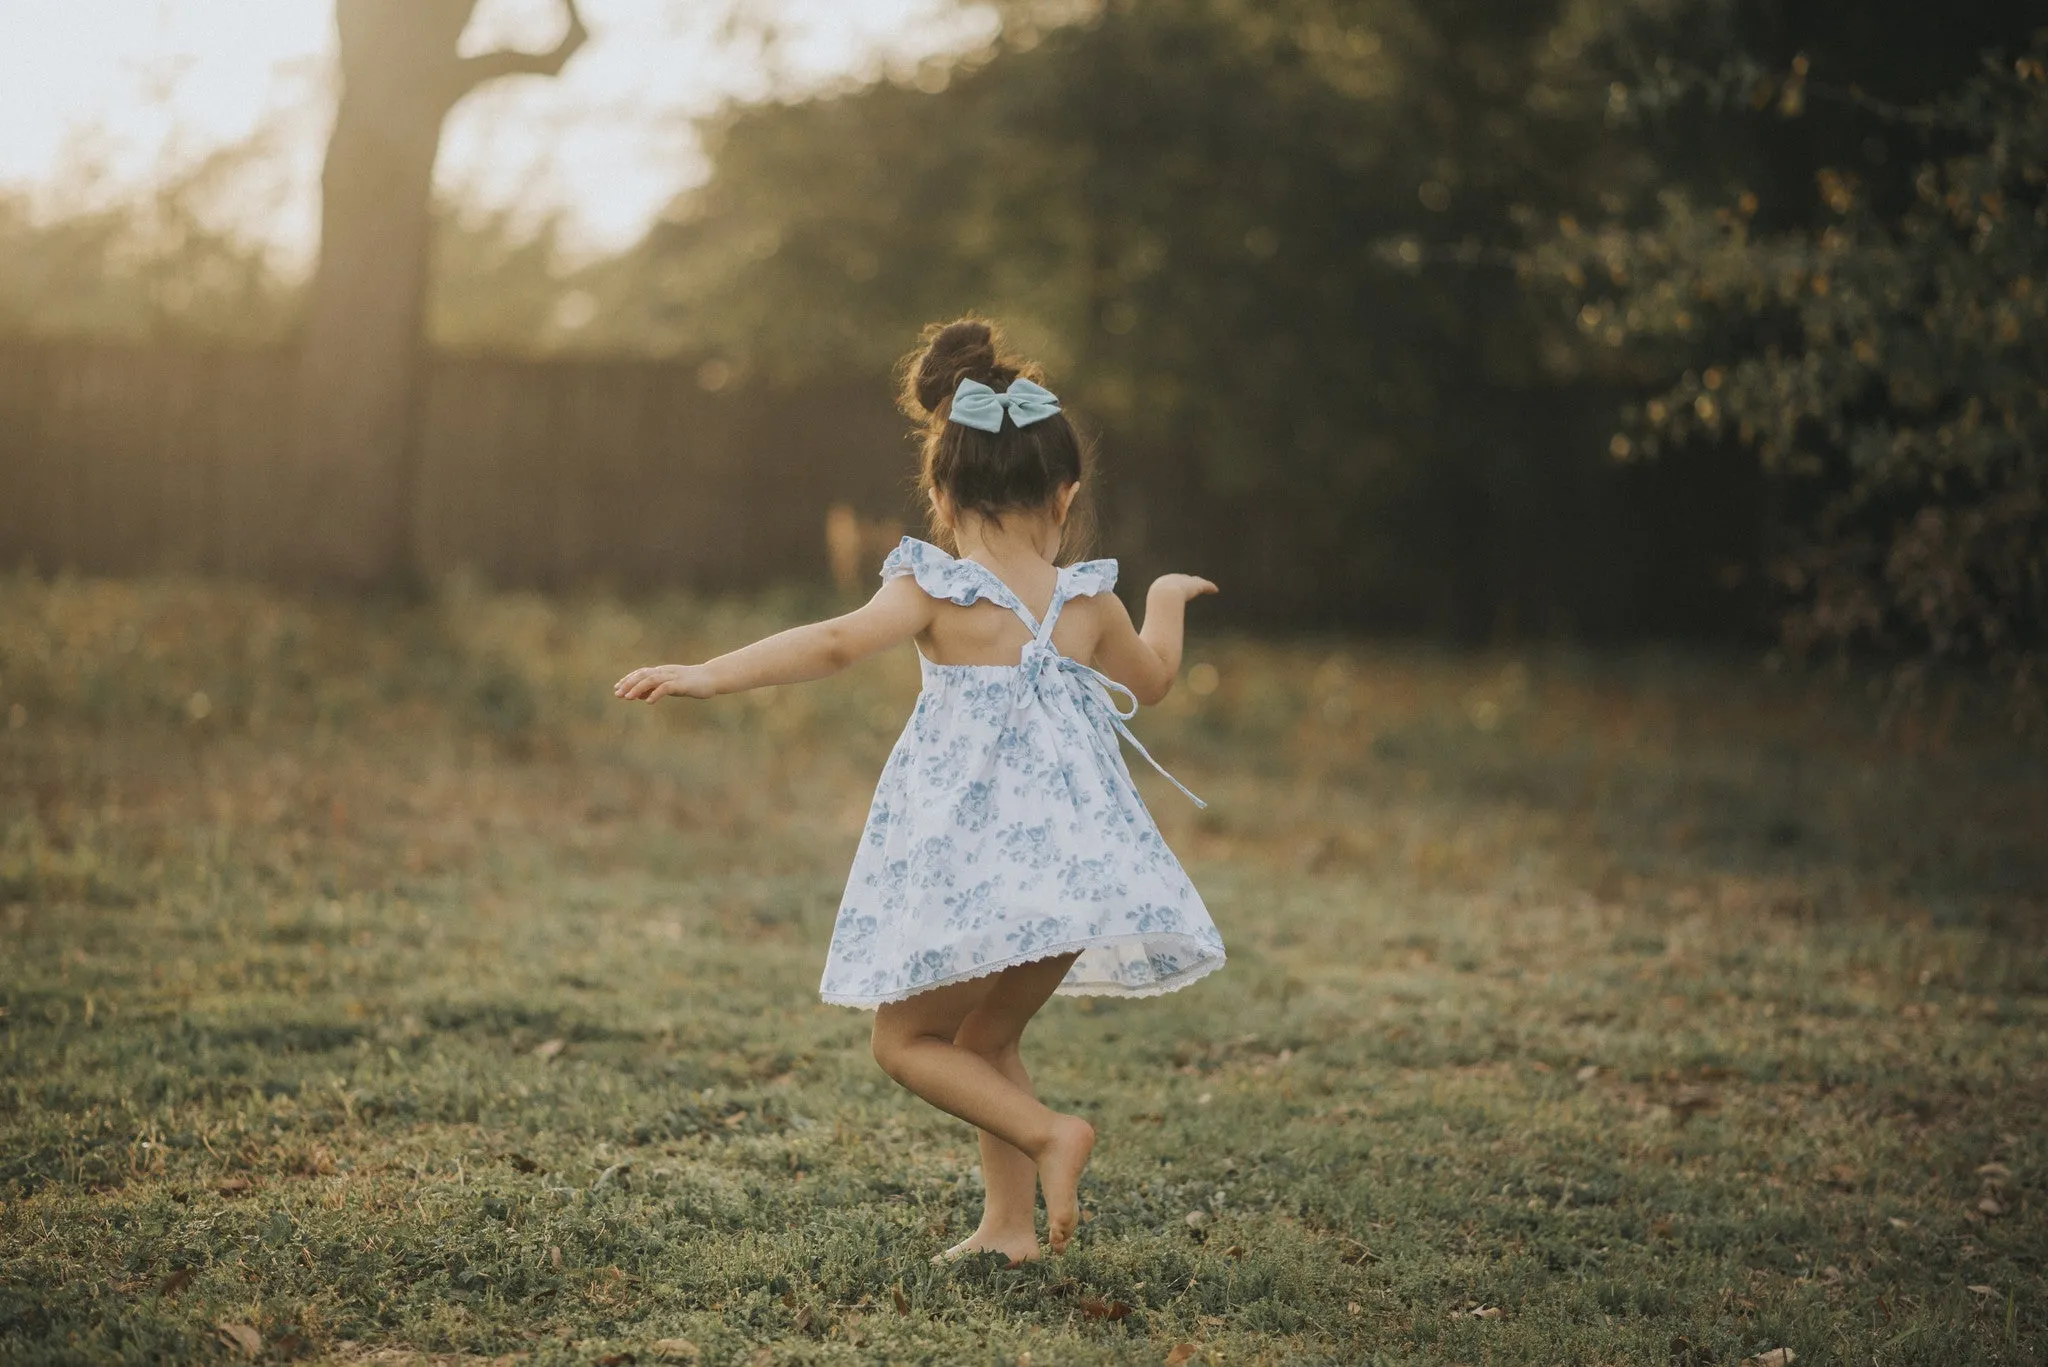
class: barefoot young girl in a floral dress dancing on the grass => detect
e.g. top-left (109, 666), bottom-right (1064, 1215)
top-left (616, 320), bottom-right (1223, 1262)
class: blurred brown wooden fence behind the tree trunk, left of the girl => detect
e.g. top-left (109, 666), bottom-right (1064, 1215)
top-left (0, 342), bottom-right (911, 588)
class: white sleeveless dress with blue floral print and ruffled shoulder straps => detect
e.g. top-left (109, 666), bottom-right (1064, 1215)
top-left (819, 537), bottom-right (1223, 1006)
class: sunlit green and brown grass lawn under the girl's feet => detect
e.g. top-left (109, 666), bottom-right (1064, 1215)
top-left (0, 580), bottom-right (2048, 1367)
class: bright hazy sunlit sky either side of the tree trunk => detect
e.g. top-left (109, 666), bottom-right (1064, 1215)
top-left (0, 0), bottom-right (995, 260)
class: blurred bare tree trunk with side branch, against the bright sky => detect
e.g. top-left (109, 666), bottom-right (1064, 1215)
top-left (281, 0), bottom-right (586, 584)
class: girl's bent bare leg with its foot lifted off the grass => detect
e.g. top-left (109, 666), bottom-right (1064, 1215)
top-left (874, 959), bottom-right (1096, 1252)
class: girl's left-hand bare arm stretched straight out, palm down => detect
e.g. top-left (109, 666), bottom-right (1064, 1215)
top-left (612, 576), bottom-right (936, 703)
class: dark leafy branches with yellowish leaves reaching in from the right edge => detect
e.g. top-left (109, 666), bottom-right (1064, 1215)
top-left (1530, 35), bottom-right (2048, 713)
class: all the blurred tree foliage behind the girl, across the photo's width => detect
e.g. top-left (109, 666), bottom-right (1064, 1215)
top-left (0, 0), bottom-right (2048, 655)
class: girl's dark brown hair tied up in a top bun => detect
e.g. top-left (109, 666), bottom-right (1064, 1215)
top-left (899, 318), bottom-right (1090, 549)
